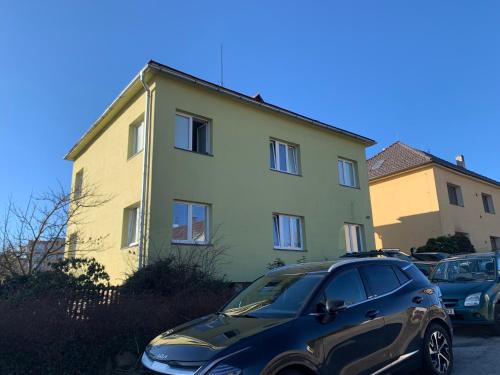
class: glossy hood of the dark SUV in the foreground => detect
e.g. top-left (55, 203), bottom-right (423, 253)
top-left (146, 314), bottom-right (291, 362)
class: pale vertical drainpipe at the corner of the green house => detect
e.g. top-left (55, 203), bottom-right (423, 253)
top-left (138, 69), bottom-right (151, 269)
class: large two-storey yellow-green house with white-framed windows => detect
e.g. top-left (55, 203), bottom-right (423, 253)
top-left (66, 61), bottom-right (374, 283)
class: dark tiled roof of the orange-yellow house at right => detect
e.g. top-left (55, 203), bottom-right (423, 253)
top-left (367, 142), bottom-right (500, 187)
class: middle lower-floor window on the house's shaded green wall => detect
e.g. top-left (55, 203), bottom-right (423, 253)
top-left (273, 214), bottom-right (304, 250)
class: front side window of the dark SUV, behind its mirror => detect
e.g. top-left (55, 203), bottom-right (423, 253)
top-left (325, 268), bottom-right (367, 306)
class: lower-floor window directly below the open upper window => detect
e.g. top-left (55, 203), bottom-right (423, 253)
top-left (172, 201), bottom-right (209, 244)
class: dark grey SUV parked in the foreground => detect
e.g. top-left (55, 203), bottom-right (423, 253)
top-left (142, 258), bottom-right (453, 375)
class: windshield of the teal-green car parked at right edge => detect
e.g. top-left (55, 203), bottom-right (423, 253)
top-left (431, 257), bottom-right (496, 282)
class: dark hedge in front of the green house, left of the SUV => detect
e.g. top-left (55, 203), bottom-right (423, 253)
top-left (0, 251), bottom-right (232, 375)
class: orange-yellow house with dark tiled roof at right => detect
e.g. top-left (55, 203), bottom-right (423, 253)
top-left (367, 142), bottom-right (500, 251)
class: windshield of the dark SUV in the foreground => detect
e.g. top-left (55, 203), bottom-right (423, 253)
top-left (222, 272), bottom-right (326, 318)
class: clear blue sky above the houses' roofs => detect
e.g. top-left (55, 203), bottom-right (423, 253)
top-left (0, 0), bottom-right (500, 206)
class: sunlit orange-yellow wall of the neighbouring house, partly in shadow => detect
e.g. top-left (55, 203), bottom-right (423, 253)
top-left (370, 166), bottom-right (441, 253)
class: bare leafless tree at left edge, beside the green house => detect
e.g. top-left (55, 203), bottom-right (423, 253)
top-left (0, 186), bottom-right (109, 277)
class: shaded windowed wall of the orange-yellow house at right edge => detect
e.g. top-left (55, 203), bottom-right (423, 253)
top-left (434, 166), bottom-right (500, 251)
